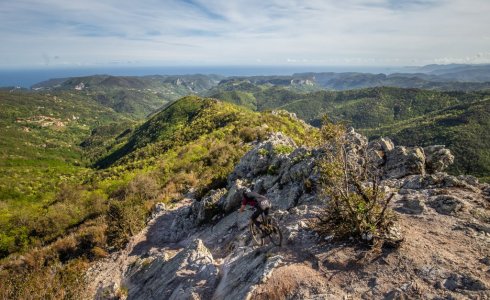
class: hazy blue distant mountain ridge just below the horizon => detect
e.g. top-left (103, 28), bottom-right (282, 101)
top-left (31, 64), bottom-right (490, 96)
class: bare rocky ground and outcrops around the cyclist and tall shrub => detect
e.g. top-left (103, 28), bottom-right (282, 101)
top-left (87, 131), bottom-right (490, 299)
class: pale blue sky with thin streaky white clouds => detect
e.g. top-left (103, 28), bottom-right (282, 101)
top-left (0, 0), bottom-right (490, 69)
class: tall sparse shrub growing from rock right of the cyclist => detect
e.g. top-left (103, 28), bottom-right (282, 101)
top-left (315, 119), bottom-right (394, 245)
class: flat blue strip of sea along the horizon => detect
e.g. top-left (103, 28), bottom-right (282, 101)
top-left (0, 66), bottom-right (407, 88)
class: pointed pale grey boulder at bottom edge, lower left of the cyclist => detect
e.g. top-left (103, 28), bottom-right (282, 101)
top-left (127, 240), bottom-right (218, 299)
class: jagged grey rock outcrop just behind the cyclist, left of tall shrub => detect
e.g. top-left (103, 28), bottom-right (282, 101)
top-left (226, 133), bottom-right (321, 211)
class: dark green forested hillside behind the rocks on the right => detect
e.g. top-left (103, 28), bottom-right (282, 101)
top-left (209, 87), bottom-right (490, 177)
